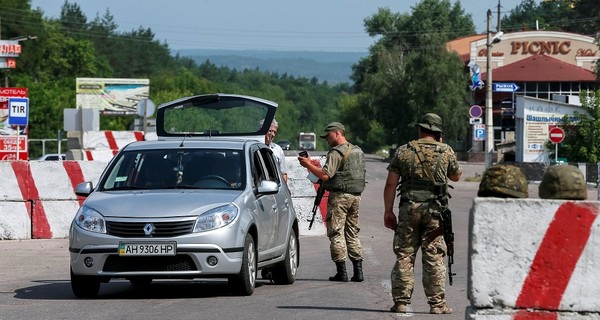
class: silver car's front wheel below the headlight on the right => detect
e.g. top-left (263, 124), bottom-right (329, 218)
top-left (229, 234), bottom-right (257, 296)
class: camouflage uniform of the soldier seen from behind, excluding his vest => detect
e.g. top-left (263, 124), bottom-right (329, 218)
top-left (387, 136), bottom-right (462, 313)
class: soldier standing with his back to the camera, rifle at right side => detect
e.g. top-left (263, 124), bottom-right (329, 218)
top-left (383, 113), bottom-right (462, 314)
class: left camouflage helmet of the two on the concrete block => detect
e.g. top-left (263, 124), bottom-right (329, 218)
top-left (477, 164), bottom-right (529, 198)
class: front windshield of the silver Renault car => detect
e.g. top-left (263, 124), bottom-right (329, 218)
top-left (100, 149), bottom-right (246, 191)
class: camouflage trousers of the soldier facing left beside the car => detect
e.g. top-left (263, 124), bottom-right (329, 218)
top-left (325, 192), bottom-right (362, 262)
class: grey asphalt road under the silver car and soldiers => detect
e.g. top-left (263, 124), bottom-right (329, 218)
top-left (0, 156), bottom-right (595, 320)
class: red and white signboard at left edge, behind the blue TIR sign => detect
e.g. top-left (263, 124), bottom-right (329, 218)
top-left (0, 88), bottom-right (29, 160)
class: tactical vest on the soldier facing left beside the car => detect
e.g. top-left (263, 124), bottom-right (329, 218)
top-left (323, 144), bottom-right (366, 194)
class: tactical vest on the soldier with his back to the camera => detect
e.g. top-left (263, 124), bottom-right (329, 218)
top-left (400, 141), bottom-right (448, 203)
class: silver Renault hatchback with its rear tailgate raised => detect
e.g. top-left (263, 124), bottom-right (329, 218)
top-left (69, 94), bottom-right (300, 298)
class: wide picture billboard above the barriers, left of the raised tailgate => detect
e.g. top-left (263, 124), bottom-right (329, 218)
top-left (75, 78), bottom-right (150, 115)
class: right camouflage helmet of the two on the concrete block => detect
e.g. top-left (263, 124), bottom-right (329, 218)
top-left (539, 165), bottom-right (587, 200)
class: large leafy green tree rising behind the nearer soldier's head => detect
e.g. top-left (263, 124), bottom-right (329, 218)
top-left (352, 0), bottom-right (474, 152)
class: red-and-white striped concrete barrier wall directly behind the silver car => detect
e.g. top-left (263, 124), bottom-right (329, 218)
top-left (0, 156), bottom-right (326, 240)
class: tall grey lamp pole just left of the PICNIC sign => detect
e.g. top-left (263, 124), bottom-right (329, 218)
top-left (485, 9), bottom-right (504, 169)
